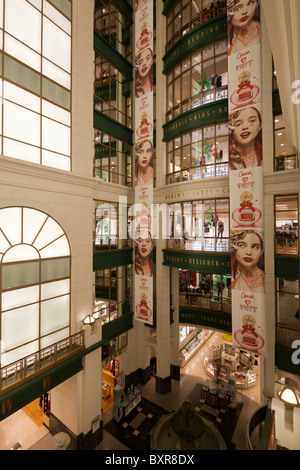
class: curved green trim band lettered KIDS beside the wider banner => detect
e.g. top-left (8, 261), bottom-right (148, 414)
top-left (163, 99), bottom-right (228, 142)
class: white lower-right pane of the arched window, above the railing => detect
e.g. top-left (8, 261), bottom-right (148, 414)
top-left (41, 295), bottom-right (69, 336)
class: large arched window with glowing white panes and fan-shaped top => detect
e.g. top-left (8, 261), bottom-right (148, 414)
top-left (0, 207), bottom-right (71, 367)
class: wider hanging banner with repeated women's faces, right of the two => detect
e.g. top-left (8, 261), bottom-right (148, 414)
top-left (227, 0), bottom-right (266, 356)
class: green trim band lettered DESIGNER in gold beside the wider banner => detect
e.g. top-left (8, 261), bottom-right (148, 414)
top-left (163, 250), bottom-right (231, 274)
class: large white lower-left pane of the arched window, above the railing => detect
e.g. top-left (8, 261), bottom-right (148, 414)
top-left (1, 304), bottom-right (39, 349)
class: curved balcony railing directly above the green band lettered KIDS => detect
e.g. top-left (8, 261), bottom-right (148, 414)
top-left (166, 85), bottom-right (228, 121)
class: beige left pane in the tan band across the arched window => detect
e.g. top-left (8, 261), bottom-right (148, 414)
top-left (2, 261), bottom-right (39, 290)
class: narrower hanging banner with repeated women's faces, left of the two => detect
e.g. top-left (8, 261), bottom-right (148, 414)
top-left (134, 0), bottom-right (154, 325)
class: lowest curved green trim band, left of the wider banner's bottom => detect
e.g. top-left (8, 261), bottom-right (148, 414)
top-left (179, 307), bottom-right (232, 334)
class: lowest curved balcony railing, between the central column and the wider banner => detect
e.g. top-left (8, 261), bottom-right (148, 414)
top-left (179, 292), bottom-right (231, 315)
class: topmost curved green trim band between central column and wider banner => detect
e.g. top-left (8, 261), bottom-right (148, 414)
top-left (163, 15), bottom-right (227, 75)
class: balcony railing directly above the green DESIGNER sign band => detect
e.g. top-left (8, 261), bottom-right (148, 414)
top-left (167, 237), bottom-right (230, 253)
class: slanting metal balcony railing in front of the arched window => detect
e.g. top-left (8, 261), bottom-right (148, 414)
top-left (0, 331), bottom-right (84, 391)
